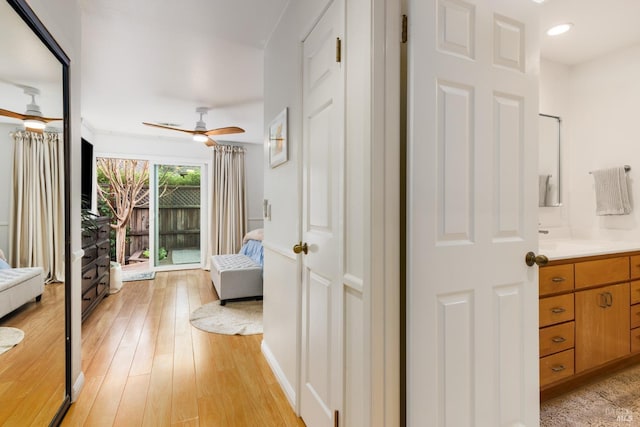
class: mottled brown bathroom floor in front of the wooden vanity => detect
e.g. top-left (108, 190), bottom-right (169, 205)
top-left (540, 366), bottom-right (640, 427)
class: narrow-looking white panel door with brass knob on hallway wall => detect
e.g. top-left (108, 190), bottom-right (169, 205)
top-left (300, 0), bottom-right (344, 427)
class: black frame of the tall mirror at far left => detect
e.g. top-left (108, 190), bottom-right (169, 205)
top-left (7, 0), bottom-right (72, 426)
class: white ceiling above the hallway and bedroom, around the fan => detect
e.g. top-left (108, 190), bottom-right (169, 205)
top-left (81, 0), bottom-right (287, 143)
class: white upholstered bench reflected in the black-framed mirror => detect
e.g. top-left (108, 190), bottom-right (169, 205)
top-left (0, 267), bottom-right (44, 317)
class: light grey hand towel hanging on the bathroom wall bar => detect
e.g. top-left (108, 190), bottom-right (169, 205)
top-left (593, 166), bottom-right (631, 215)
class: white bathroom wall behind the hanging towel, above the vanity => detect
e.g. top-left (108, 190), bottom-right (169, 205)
top-left (541, 45), bottom-right (640, 240)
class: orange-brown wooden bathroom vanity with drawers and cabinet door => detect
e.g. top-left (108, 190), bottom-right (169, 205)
top-left (539, 245), bottom-right (640, 400)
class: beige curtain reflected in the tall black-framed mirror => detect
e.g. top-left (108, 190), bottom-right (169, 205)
top-left (9, 131), bottom-right (64, 282)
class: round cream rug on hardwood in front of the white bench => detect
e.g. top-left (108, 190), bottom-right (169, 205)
top-left (190, 301), bottom-right (262, 335)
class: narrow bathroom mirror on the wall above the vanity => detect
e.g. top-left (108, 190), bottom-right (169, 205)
top-left (538, 114), bottom-right (562, 207)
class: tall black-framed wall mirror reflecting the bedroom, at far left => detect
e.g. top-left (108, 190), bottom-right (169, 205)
top-left (0, 0), bottom-right (71, 425)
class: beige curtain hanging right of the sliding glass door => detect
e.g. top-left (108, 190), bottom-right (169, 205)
top-left (207, 145), bottom-right (247, 265)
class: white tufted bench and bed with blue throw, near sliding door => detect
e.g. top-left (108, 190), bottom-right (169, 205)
top-left (211, 229), bottom-right (264, 305)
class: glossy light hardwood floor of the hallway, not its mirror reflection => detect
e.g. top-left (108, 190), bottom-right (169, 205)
top-left (62, 270), bottom-right (304, 427)
